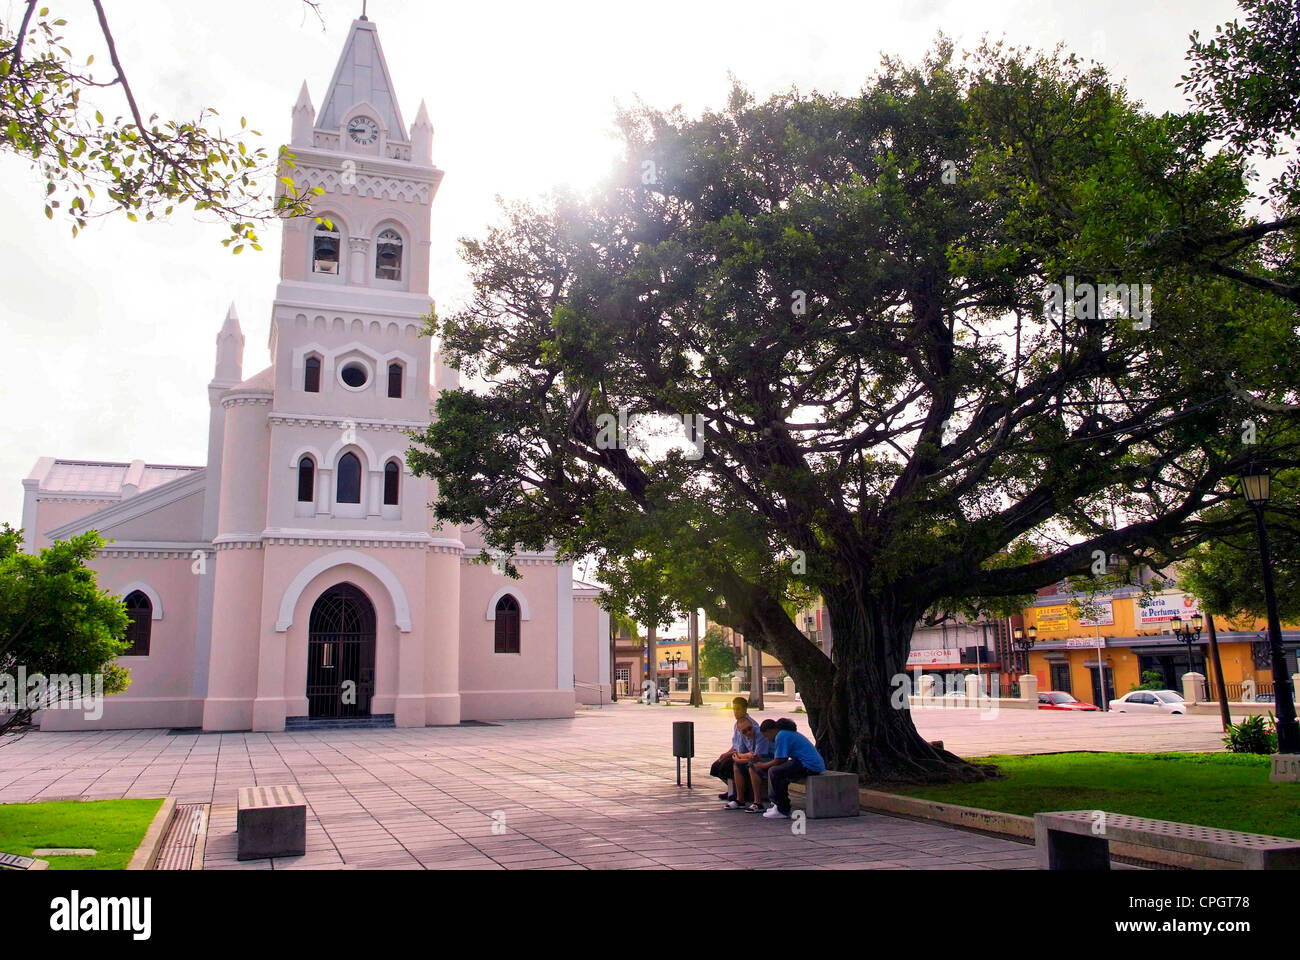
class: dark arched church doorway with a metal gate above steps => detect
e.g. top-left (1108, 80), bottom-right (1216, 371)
top-left (307, 583), bottom-right (374, 717)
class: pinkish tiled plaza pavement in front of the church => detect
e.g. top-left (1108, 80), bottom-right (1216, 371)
top-left (0, 702), bottom-right (1221, 869)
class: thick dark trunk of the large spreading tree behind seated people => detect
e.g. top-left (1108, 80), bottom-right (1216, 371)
top-left (803, 587), bottom-right (989, 782)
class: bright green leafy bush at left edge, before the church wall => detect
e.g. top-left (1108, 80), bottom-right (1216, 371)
top-left (0, 524), bottom-right (130, 734)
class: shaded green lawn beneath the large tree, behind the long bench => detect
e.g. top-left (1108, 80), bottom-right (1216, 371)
top-left (880, 753), bottom-right (1300, 838)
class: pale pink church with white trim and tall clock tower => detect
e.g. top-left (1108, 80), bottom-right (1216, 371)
top-left (22, 17), bottom-right (610, 731)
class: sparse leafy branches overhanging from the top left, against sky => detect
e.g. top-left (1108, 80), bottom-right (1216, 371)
top-left (0, 0), bottom-right (321, 243)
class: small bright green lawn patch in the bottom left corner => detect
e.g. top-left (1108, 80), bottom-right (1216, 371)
top-left (0, 799), bottom-right (163, 870)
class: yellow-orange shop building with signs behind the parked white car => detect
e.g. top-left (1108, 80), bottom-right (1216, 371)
top-left (1023, 589), bottom-right (1300, 705)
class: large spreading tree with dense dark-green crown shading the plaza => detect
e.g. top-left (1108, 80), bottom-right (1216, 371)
top-left (410, 27), bottom-right (1300, 778)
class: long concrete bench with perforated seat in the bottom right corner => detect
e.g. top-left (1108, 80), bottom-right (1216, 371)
top-left (1034, 810), bottom-right (1300, 870)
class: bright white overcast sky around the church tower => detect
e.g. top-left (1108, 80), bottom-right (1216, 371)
top-left (0, 0), bottom-right (1238, 526)
